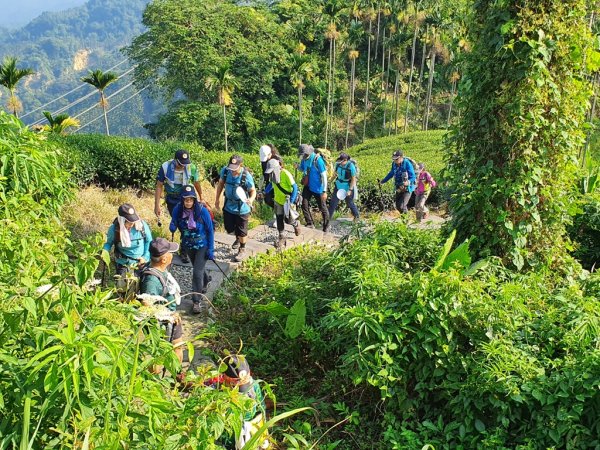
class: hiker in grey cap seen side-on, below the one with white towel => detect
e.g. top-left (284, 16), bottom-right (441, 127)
top-left (139, 238), bottom-right (183, 363)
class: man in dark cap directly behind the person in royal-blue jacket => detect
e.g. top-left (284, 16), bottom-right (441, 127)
top-left (154, 149), bottom-right (202, 264)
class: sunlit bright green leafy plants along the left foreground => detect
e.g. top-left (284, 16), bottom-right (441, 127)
top-left (0, 112), bottom-right (270, 450)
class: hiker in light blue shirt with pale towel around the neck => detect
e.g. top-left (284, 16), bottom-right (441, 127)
top-left (103, 203), bottom-right (152, 276)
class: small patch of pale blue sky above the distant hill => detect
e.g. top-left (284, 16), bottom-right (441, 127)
top-left (0, 0), bottom-right (86, 28)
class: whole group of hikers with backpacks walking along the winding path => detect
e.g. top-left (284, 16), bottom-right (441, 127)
top-left (98, 144), bottom-right (435, 448)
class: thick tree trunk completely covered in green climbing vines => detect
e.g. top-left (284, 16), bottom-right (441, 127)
top-left (448, 0), bottom-right (597, 269)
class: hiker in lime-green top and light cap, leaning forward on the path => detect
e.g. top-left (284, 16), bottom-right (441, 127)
top-left (265, 159), bottom-right (300, 248)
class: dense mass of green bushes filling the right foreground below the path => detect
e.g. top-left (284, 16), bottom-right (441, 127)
top-left (218, 224), bottom-right (600, 449)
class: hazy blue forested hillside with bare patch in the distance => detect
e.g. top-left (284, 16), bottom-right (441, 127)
top-left (0, 0), bottom-right (152, 135)
